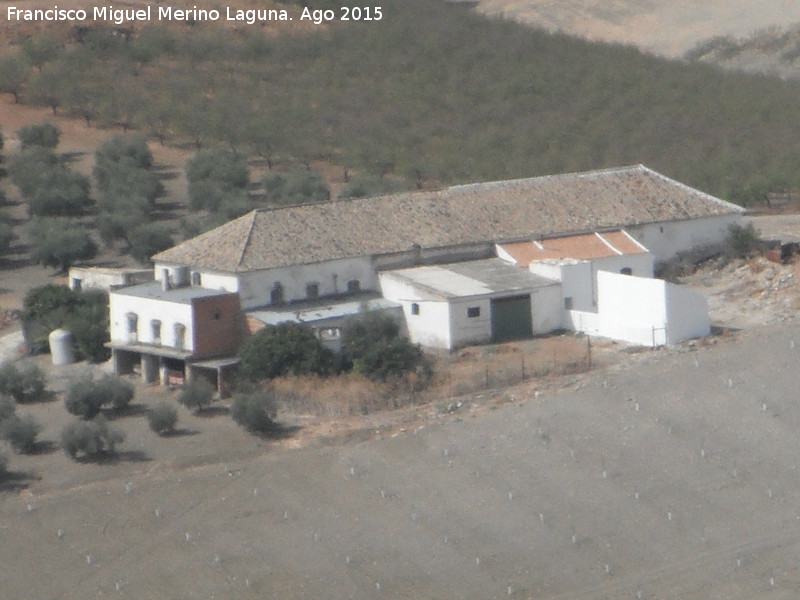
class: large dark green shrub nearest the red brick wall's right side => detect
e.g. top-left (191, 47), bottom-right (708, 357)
top-left (239, 322), bottom-right (334, 380)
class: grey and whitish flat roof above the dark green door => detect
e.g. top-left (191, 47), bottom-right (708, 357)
top-left (381, 258), bottom-right (558, 298)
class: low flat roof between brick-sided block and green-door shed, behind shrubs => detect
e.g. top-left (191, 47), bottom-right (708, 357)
top-left (245, 294), bottom-right (401, 325)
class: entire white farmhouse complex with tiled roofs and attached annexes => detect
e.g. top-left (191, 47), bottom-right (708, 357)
top-left (110, 165), bottom-right (743, 390)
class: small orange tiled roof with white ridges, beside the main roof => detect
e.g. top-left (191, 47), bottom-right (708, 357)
top-left (501, 230), bottom-right (647, 266)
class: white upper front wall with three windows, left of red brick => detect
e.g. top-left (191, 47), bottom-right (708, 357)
top-left (109, 293), bottom-right (194, 351)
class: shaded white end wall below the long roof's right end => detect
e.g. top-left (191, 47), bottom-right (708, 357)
top-left (625, 214), bottom-right (742, 263)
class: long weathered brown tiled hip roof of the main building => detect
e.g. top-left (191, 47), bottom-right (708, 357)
top-left (153, 165), bottom-right (742, 272)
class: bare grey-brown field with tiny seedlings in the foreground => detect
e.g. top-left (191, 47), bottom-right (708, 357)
top-left (0, 323), bottom-right (800, 600)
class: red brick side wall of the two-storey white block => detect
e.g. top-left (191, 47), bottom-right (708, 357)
top-left (192, 294), bottom-right (242, 356)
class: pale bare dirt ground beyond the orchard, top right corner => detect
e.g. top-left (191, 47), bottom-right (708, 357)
top-left (468, 0), bottom-right (800, 57)
